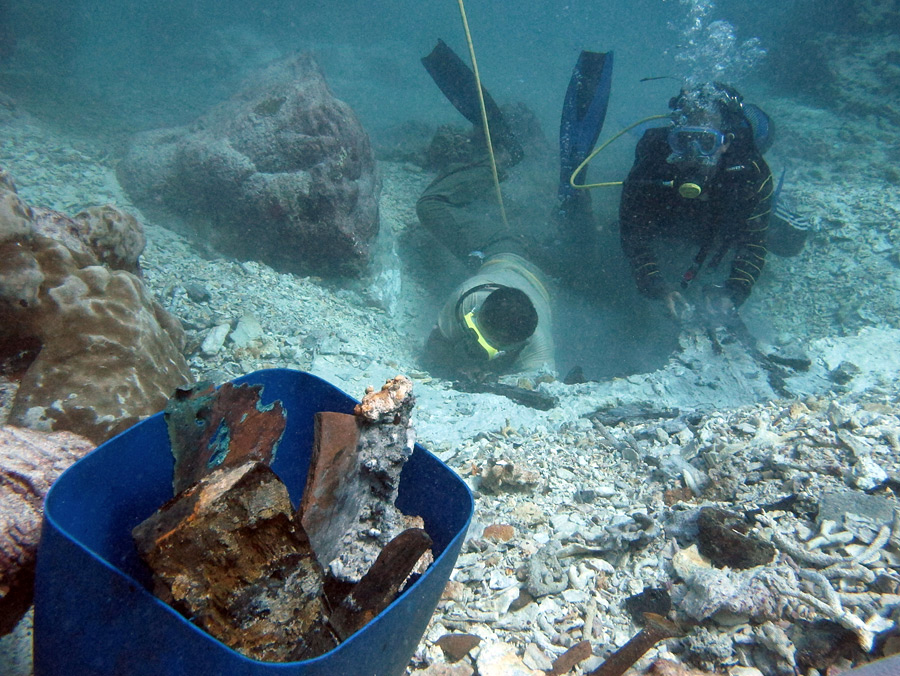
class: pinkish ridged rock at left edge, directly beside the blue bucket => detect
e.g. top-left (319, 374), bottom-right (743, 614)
top-left (0, 426), bottom-right (94, 636)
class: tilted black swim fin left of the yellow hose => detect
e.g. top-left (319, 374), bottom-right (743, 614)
top-left (422, 40), bottom-right (522, 163)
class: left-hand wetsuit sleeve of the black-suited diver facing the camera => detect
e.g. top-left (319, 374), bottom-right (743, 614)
top-left (619, 130), bottom-right (668, 298)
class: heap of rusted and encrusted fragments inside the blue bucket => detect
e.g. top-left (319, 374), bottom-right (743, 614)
top-left (133, 376), bottom-right (431, 662)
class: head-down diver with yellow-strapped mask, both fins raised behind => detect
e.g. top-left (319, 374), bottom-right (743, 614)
top-left (416, 41), bottom-right (612, 376)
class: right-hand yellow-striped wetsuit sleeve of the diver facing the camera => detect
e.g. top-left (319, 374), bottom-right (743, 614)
top-left (725, 157), bottom-right (775, 306)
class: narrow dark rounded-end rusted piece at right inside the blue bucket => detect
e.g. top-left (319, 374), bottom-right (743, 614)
top-left (331, 528), bottom-right (431, 640)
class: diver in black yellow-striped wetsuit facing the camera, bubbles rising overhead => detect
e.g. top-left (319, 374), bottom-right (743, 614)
top-left (619, 83), bottom-right (775, 317)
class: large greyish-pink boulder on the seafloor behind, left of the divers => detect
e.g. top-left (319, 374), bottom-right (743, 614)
top-left (118, 49), bottom-right (380, 275)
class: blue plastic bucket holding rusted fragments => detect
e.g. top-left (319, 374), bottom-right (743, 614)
top-left (34, 369), bottom-right (473, 676)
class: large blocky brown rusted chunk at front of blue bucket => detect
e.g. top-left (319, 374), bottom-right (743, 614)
top-left (132, 462), bottom-right (337, 662)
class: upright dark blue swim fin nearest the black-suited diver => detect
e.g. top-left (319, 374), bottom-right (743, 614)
top-left (559, 51), bottom-right (613, 203)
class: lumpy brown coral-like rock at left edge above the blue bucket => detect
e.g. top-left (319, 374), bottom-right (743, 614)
top-left (0, 171), bottom-right (189, 443)
